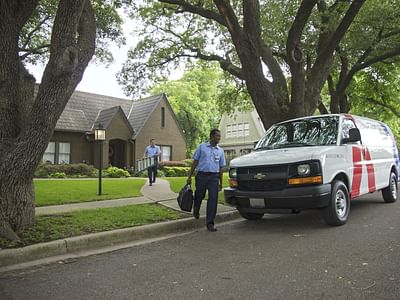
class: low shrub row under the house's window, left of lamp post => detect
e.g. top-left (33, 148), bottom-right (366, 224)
top-left (35, 163), bottom-right (98, 177)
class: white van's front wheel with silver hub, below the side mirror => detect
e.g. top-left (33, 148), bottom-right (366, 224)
top-left (322, 180), bottom-right (350, 226)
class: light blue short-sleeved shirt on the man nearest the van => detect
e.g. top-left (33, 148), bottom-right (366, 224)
top-left (193, 142), bottom-right (225, 173)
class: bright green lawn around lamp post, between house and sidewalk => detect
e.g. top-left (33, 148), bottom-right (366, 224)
top-left (34, 178), bottom-right (146, 206)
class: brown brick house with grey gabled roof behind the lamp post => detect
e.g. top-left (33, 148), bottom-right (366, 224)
top-left (43, 91), bottom-right (186, 168)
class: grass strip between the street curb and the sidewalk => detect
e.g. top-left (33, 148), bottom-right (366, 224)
top-left (0, 204), bottom-right (187, 248)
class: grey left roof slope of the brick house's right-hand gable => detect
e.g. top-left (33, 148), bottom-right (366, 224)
top-left (128, 94), bottom-right (164, 137)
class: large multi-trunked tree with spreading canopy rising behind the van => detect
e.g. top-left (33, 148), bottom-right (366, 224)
top-left (119, 0), bottom-right (400, 127)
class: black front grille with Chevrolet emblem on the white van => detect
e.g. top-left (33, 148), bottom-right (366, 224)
top-left (237, 165), bottom-right (288, 191)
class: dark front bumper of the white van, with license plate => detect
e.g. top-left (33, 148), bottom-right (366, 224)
top-left (224, 183), bottom-right (331, 213)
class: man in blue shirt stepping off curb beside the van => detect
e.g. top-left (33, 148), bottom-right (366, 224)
top-left (187, 129), bottom-right (225, 231)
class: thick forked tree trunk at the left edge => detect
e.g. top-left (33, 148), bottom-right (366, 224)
top-left (0, 0), bottom-right (96, 239)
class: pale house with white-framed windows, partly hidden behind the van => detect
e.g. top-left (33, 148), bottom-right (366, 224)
top-left (219, 110), bottom-right (265, 163)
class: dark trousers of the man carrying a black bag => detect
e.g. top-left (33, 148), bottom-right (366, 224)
top-left (193, 172), bottom-right (219, 224)
